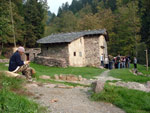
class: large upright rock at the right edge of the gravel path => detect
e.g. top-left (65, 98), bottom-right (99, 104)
top-left (92, 81), bottom-right (105, 93)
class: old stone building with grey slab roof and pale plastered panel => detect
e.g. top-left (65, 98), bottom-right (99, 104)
top-left (35, 29), bottom-right (109, 67)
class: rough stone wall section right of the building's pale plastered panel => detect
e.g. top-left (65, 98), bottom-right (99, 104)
top-left (84, 36), bottom-right (100, 67)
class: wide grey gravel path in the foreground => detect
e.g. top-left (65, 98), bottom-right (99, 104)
top-left (27, 71), bottom-right (125, 113)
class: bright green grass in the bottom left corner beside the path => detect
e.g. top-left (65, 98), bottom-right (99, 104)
top-left (0, 89), bottom-right (45, 113)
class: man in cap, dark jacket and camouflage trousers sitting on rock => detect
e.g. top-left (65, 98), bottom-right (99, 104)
top-left (9, 47), bottom-right (34, 79)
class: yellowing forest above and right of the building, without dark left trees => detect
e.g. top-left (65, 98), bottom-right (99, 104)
top-left (46, 0), bottom-right (150, 63)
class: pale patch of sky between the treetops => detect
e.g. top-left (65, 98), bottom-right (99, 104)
top-left (47, 0), bottom-right (72, 14)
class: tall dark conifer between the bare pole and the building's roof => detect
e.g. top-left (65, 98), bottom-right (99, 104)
top-left (24, 0), bottom-right (45, 47)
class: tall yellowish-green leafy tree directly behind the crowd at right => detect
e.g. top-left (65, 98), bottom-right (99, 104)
top-left (112, 1), bottom-right (140, 55)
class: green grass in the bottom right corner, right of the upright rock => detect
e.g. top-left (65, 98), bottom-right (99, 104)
top-left (91, 84), bottom-right (150, 113)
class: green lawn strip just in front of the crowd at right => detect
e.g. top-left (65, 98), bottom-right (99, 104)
top-left (109, 69), bottom-right (150, 83)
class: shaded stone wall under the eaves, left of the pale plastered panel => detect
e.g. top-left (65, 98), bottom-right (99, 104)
top-left (40, 43), bottom-right (69, 65)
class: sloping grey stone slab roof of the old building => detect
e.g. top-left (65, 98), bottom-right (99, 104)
top-left (37, 29), bottom-right (109, 44)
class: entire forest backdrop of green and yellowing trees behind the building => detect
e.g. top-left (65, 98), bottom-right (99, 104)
top-left (0, 0), bottom-right (150, 63)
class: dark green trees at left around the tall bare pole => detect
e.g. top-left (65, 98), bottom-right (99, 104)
top-left (0, 0), bottom-right (47, 49)
